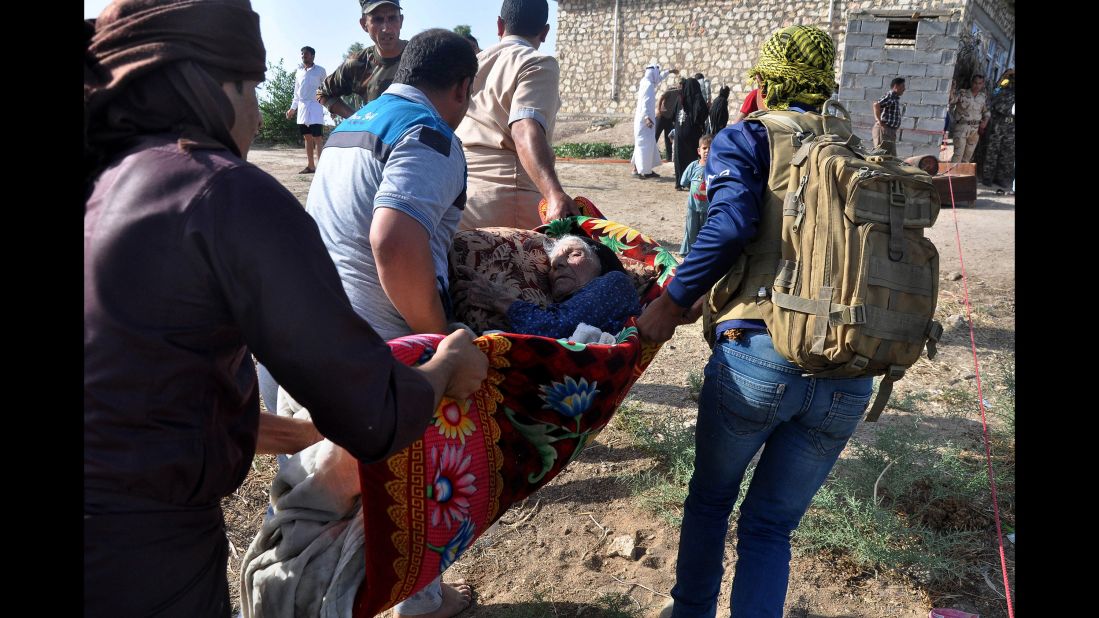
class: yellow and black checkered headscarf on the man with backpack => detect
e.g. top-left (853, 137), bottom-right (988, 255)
top-left (748, 25), bottom-right (839, 110)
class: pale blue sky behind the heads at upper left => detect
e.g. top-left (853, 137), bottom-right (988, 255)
top-left (84, 0), bottom-right (557, 78)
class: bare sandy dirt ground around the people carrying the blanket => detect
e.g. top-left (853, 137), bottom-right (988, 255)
top-left (225, 122), bottom-right (1015, 618)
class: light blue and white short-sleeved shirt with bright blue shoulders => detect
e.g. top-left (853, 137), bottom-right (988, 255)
top-left (305, 84), bottom-right (466, 339)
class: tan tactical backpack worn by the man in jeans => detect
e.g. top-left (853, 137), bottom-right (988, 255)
top-left (720, 108), bottom-right (943, 421)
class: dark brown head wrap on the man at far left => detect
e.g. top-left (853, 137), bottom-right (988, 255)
top-left (84, 0), bottom-right (266, 178)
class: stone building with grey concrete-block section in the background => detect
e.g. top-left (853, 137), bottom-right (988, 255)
top-left (557, 0), bottom-right (1015, 156)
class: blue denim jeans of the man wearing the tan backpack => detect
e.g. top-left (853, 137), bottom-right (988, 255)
top-left (671, 331), bottom-right (874, 618)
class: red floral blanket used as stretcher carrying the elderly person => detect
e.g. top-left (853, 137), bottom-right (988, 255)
top-left (354, 198), bottom-right (677, 618)
